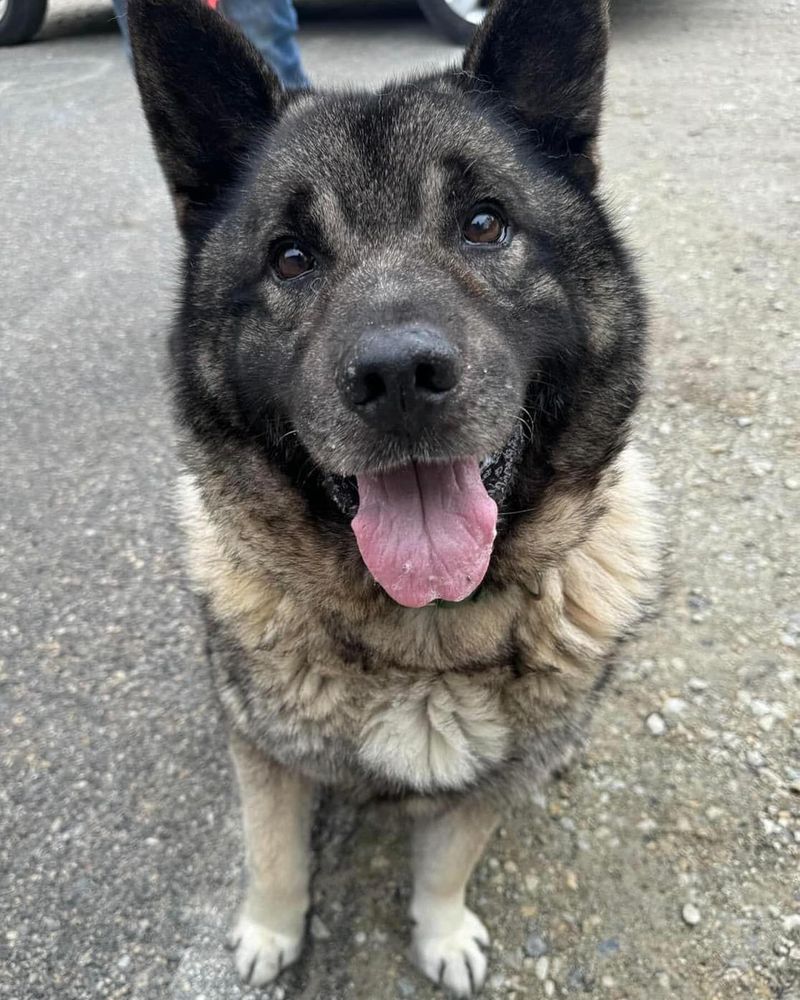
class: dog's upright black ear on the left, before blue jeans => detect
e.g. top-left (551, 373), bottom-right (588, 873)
top-left (128, 0), bottom-right (285, 237)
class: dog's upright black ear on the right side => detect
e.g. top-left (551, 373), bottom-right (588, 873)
top-left (464, 0), bottom-right (608, 189)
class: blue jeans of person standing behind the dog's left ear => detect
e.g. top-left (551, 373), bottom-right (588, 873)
top-left (113, 0), bottom-right (309, 90)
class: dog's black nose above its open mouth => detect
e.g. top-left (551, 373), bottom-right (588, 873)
top-left (342, 329), bottom-right (460, 431)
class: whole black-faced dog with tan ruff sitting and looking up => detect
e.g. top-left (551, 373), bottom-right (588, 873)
top-left (129, 0), bottom-right (659, 996)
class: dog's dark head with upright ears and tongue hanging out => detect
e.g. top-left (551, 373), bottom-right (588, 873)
top-left (129, 0), bottom-right (642, 606)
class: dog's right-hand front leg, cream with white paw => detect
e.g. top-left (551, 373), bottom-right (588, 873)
top-left (411, 800), bottom-right (497, 996)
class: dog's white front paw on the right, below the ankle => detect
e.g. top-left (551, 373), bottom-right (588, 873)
top-left (411, 909), bottom-right (489, 997)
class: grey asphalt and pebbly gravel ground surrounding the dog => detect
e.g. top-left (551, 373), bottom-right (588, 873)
top-left (0, 0), bottom-right (800, 1000)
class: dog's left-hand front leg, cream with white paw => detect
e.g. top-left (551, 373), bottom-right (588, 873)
top-left (229, 735), bottom-right (313, 986)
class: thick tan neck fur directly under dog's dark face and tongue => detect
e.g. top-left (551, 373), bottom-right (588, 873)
top-left (181, 436), bottom-right (657, 671)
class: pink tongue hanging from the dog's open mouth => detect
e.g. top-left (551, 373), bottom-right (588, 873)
top-left (353, 459), bottom-right (497, 608)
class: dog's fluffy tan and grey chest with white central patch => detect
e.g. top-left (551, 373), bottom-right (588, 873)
top-left (184, 455), bottom-right (658, 792)
